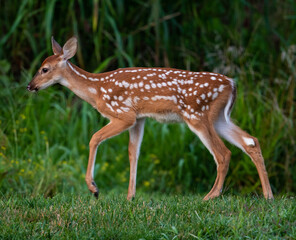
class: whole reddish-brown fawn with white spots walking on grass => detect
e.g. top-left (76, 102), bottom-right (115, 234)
top-left (28, 37), bottom-right (273, 200)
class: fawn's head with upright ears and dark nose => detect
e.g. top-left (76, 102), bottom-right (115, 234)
top-left (27, 37), bottom-right (77, 92)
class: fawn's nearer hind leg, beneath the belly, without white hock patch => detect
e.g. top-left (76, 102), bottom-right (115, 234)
top-left (187, 123), bottom-right (231, 200)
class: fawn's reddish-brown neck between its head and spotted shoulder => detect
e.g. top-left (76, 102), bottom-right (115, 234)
top-left (59, 61), bottom-right (101, 107)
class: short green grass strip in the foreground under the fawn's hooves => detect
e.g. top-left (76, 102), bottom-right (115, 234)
top-left (0, 193), bottom-right (296, 239)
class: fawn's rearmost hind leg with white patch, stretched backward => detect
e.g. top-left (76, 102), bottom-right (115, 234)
top-left (215, 116), bottom-right (273, 199)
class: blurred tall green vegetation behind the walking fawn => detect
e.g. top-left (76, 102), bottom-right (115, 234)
top-left (0, 0), bottom-right (296, 196)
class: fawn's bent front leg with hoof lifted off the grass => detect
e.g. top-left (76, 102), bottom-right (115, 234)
top-left (85, 119), bottom-right (134, 198)
